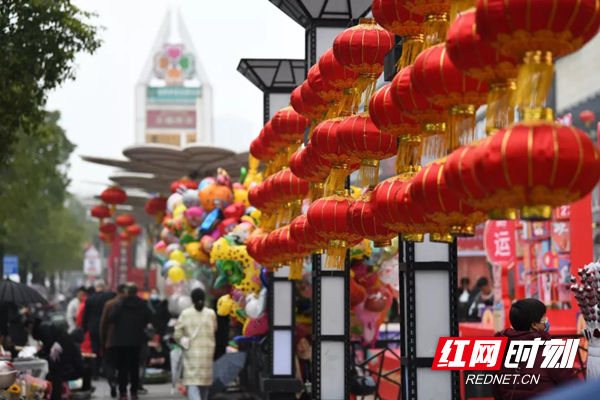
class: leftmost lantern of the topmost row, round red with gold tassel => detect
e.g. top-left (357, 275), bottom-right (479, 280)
top-left (333, 18), bottom-right (394, 114)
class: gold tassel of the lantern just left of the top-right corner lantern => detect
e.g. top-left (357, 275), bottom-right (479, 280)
top-left (485, 79), bottom-right (517, 135)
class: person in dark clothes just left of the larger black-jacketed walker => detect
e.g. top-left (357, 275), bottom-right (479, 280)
top-left (83, 279), bottom-right (116, 379)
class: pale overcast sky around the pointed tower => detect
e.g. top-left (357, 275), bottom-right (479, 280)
top-left (47, 0), bottom-right (304, 197)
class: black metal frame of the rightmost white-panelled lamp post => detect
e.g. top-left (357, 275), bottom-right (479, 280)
top-left (398, 240), bottom-right (460, 400)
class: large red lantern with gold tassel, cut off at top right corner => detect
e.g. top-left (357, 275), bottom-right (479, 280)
top-left (476, 0), bottom-right (600, 114)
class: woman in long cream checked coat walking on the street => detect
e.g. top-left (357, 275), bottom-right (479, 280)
top-left (174, 288), bottom-right (217, 400)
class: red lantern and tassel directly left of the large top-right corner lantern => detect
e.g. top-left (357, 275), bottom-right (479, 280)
top-left (446, 9), bottom-right (517, 134)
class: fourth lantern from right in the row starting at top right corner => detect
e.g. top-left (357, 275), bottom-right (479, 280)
top-left (386, 66), bottom-right (448, 159)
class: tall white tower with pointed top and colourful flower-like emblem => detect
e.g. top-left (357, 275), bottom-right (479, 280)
top-left (135, 11), bottom-right (213, 147)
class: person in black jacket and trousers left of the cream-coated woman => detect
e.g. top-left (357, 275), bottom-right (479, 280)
top-left (108, 284), bottom-right (152, 400)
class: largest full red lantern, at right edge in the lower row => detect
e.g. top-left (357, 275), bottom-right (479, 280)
top-left (474, 121), bottom-right (600, 220)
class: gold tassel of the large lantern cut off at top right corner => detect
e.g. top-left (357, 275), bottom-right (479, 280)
top-left (515, 51), bottom-right (554, 112)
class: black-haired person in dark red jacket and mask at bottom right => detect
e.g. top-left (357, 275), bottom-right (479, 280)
top-left (492, 299), bottom-right (577, 400)
